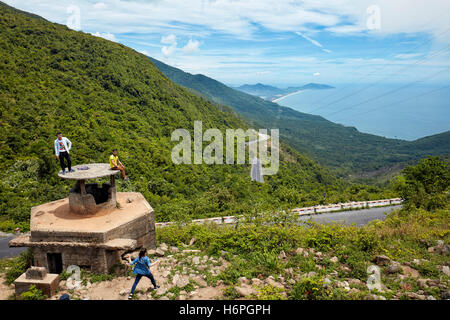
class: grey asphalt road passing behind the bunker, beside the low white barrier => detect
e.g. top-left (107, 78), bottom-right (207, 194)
top-left (0, 205), bottom-right (402, 259)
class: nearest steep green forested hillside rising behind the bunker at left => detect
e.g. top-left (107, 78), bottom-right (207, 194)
top-left (0, 3), bottom-right (394, 229)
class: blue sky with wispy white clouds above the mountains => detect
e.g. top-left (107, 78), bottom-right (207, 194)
top-left (3, 0), bottom-right (450, 87)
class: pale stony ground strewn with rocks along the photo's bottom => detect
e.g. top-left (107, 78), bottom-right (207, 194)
top-left (0, 239), bottom-right (450, 300)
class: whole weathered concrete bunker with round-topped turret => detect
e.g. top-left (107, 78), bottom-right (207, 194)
top-left (9, 163), bottom-right (156, 274)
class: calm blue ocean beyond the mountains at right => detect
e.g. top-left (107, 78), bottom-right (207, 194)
top-left (277, 84), bottom-right (450, 140)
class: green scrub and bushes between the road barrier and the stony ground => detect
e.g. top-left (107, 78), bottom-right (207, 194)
top-left (153, 158), bottom-right (450, 300)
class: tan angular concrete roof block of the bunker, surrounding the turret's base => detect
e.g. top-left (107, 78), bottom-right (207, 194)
top-left (30, 192), bottom-right (155, 243)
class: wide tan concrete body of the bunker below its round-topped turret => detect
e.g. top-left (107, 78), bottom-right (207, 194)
top-left (9, 192), bottom-right (156, 273)
